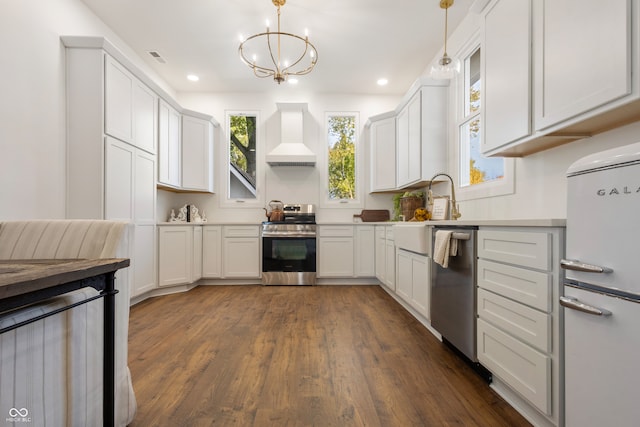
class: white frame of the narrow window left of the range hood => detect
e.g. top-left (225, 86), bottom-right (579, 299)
top-left (220, 110), bottom-right (265, 208)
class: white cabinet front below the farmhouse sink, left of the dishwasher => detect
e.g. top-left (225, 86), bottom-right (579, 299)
top-left (396, 249), bottom-right (431, 319)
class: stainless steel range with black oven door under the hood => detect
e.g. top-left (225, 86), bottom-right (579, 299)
top-left (262, 205), bottom-right (316, 285)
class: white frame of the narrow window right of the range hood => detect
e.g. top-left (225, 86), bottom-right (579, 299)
top-left (319, 111), bottom-right (364, 209)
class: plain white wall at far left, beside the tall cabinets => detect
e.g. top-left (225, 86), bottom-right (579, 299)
top-left (0, 0), bottom-right (171, 220)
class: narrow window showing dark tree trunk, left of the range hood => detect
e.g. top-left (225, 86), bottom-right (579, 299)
top-left (227, 112), bottom-right (259, 202)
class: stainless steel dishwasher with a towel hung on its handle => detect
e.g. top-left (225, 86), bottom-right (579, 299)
top-left (431, 226), bottom-right (477, 363)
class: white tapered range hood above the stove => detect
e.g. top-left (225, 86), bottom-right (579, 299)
top-left (266, 103), bottom-right (316, 166)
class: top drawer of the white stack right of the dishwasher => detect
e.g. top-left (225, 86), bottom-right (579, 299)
top-left (478, 230), bottom-right (552, 271)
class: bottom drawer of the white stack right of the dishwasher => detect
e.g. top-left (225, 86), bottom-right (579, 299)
top-left (478, 319), bottom-right (551, 415)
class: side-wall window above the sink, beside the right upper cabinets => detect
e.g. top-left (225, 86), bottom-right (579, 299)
top-left (457, 45), bottom-right (514, 200)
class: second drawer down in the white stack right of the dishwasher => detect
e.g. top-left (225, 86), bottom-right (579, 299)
top-left (478, 259), bottom-right (553, 312)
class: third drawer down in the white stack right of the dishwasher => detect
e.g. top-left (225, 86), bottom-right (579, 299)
top-left (478, 289), bottom-right (551, 353)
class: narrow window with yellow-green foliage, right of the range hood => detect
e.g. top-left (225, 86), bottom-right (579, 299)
top-left (324, 113), bottom-right (360, 207)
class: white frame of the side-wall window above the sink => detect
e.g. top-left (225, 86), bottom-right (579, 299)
top-left (453, 33), bottom-right (515, 201)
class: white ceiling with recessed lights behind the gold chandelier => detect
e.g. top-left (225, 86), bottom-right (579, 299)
top-left (82, 0), bottom-right (473, 95)
